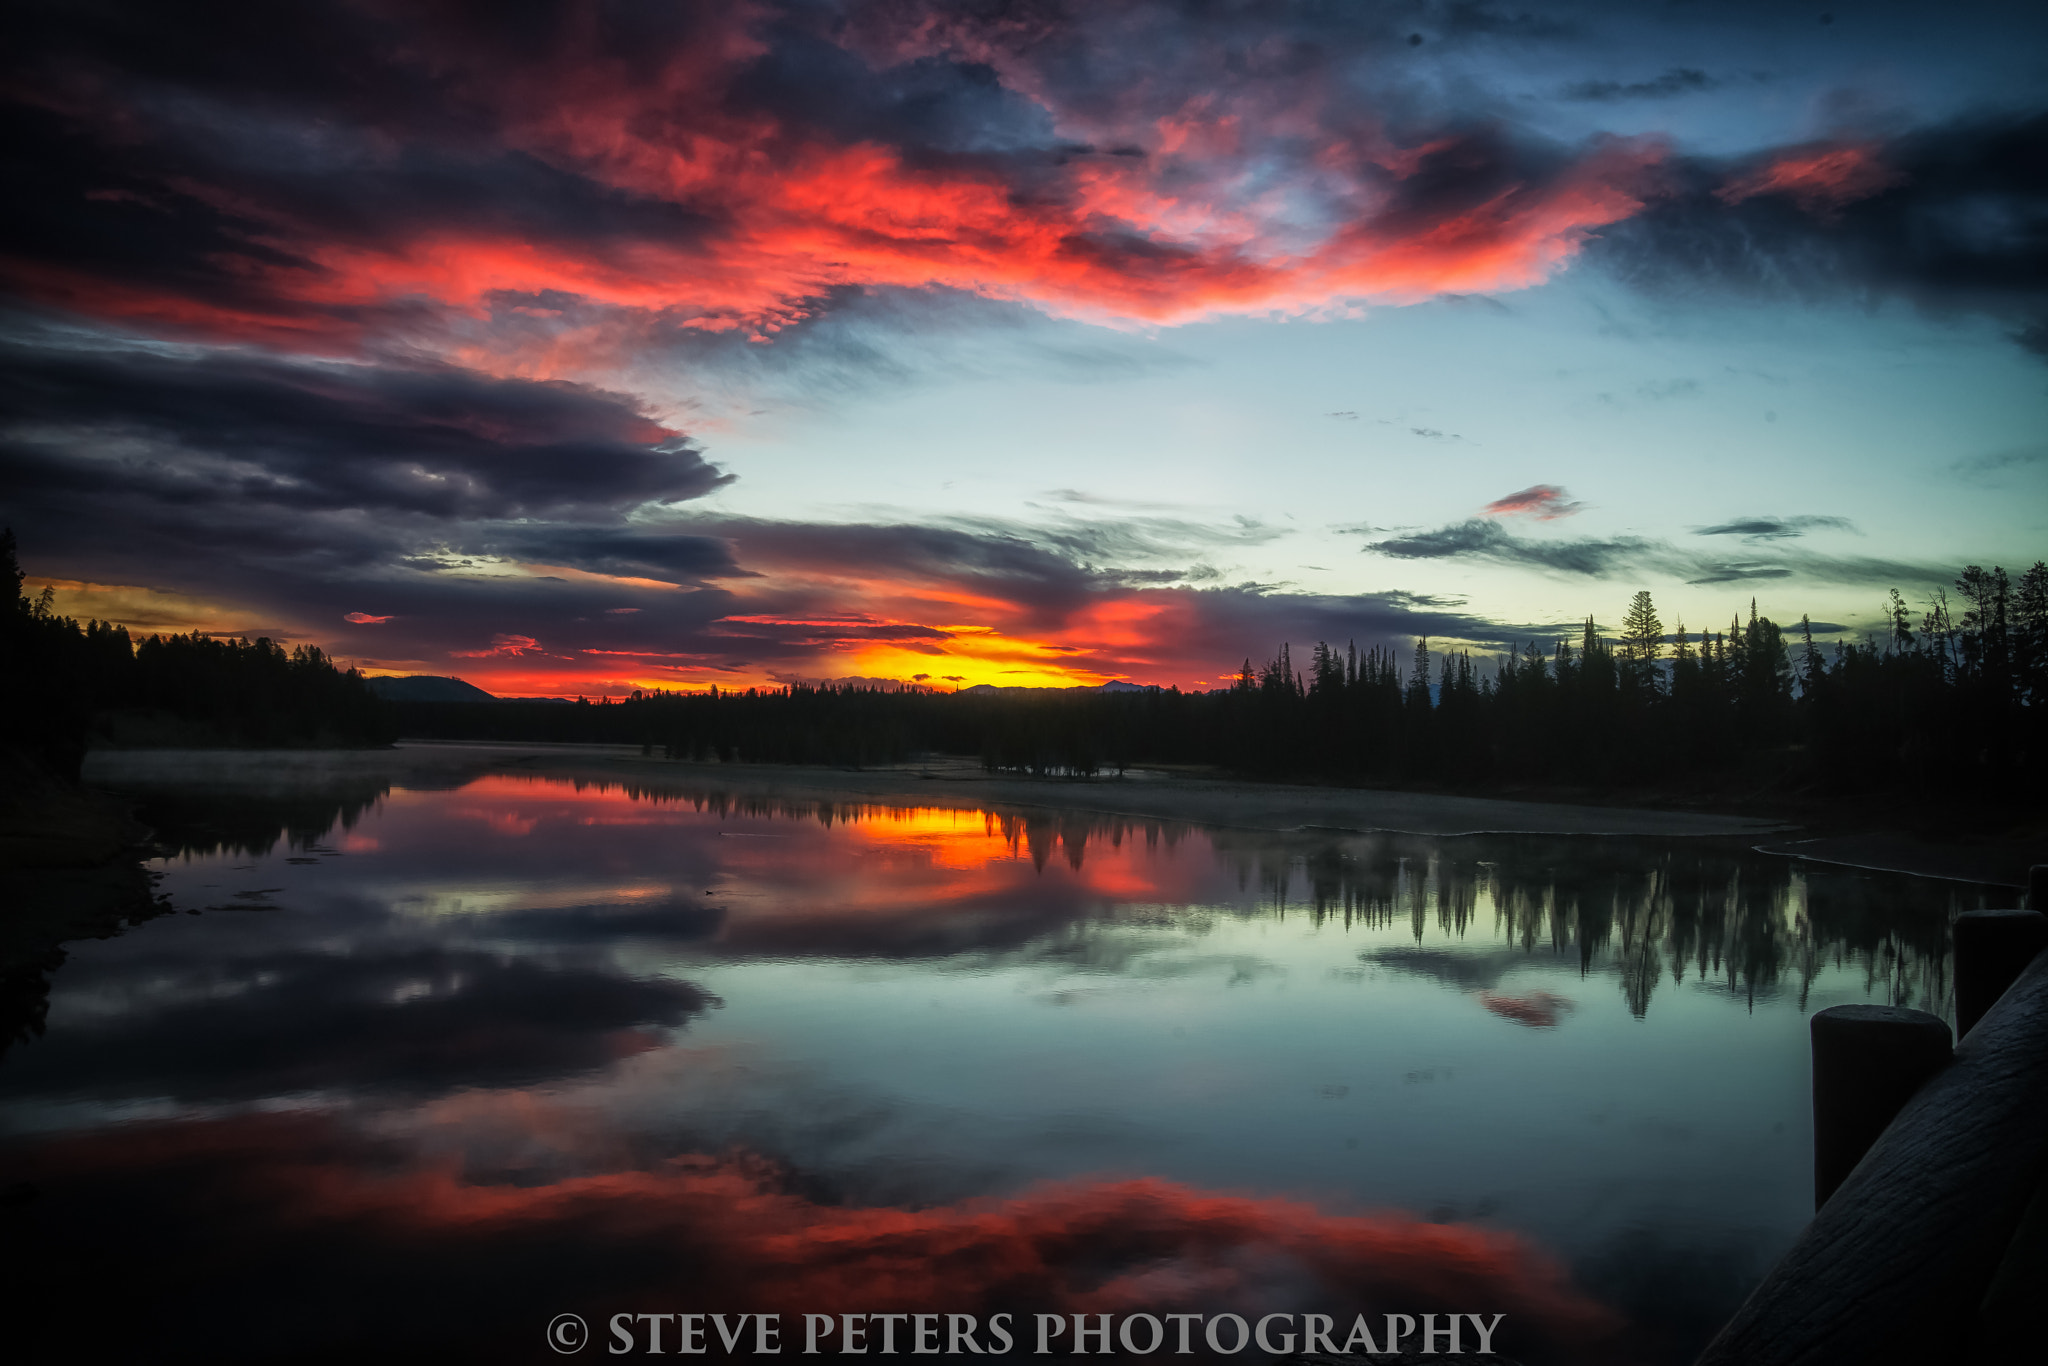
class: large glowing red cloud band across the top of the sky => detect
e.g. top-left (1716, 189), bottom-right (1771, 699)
top-left (0, 6), bottom-right (1665, 362)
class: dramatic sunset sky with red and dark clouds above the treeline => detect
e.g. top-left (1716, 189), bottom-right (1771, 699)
top-left (0, 0), bottom-right (2048, 696)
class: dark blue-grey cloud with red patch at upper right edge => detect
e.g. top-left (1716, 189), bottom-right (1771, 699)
top-left (1587, 113), bottom-right (2048, 356)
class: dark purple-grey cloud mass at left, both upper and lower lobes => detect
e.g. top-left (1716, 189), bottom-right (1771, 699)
top-left (0, 330), bottom-right (745, 657)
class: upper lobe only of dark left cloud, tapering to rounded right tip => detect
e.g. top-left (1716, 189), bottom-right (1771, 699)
top-left (0, 335), bottom-right (729, 518)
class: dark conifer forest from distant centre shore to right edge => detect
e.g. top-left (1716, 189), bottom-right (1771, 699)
top-left (393, 563), bottom-right (2048, 805)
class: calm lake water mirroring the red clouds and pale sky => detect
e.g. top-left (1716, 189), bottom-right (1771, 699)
top-left (0, 772), bottom-right (2003, 1362)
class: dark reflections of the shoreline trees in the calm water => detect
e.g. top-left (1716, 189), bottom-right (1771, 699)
top-left (119, 774), bottom-right (1997, 1016)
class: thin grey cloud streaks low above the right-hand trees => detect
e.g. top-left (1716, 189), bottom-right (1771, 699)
top-left (1364, 518), bottom-right (1950, 586)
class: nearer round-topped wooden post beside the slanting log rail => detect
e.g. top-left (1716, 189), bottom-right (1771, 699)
top-left (1812, 1006), bottom-right (1954, 1208)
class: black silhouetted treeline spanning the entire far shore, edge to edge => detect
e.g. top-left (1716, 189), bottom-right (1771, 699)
top-left (4, 535), bottom-right (2048, 805)
